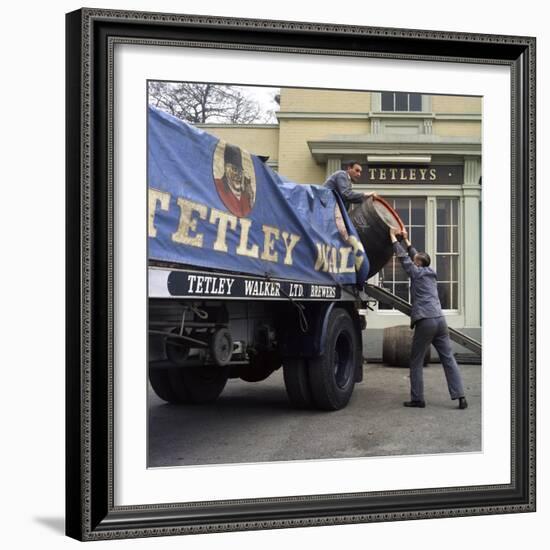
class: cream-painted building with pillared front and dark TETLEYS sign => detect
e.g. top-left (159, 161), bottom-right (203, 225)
top-left (199, 88), bottom-right (482, 359)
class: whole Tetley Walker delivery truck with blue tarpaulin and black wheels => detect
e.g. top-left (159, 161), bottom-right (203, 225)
top-left (147, 107), bottom-right (384, 410)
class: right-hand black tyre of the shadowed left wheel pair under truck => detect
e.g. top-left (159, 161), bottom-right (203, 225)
top-left (169, 366), bottom-right (229, 404)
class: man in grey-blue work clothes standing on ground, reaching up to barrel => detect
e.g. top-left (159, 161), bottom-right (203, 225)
top-left (390, 227), bottom-right (468, 409)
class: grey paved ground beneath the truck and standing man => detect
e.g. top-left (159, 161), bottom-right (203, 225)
top-left (149, 364), bottom-right (481, 467)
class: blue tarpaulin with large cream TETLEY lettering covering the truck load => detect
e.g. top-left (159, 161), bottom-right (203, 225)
top-left (148, 107), bottom-right (369, 285)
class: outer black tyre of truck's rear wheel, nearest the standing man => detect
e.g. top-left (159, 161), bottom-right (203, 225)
top-left (309, 308), bottom-right (358, 411)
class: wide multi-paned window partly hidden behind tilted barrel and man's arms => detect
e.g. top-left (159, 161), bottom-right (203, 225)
top-left (378, 197), bottom-right (426, 310)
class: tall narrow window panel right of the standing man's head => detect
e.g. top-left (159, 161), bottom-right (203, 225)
top-left (435, 199), bottom-right (464, 309)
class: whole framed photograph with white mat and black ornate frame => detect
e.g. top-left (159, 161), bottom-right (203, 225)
top-left (66, 9), bottom-right (536, 540)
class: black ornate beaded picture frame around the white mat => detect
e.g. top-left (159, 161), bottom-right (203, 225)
top-left (66, 9), bottom-right (535, 540)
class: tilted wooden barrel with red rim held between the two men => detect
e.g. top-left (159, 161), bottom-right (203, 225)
top-left (350, 197), bottom-right (404, 278)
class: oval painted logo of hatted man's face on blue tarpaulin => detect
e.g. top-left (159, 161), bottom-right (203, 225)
top-left (216, 140), bottom-right (256, 218)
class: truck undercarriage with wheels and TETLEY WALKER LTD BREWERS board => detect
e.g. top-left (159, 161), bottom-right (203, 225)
top-left (148, 267), bottom-right (366, 410)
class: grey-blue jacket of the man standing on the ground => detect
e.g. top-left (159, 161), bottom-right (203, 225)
top-left (393, 241), bottom-right (443, 327)
